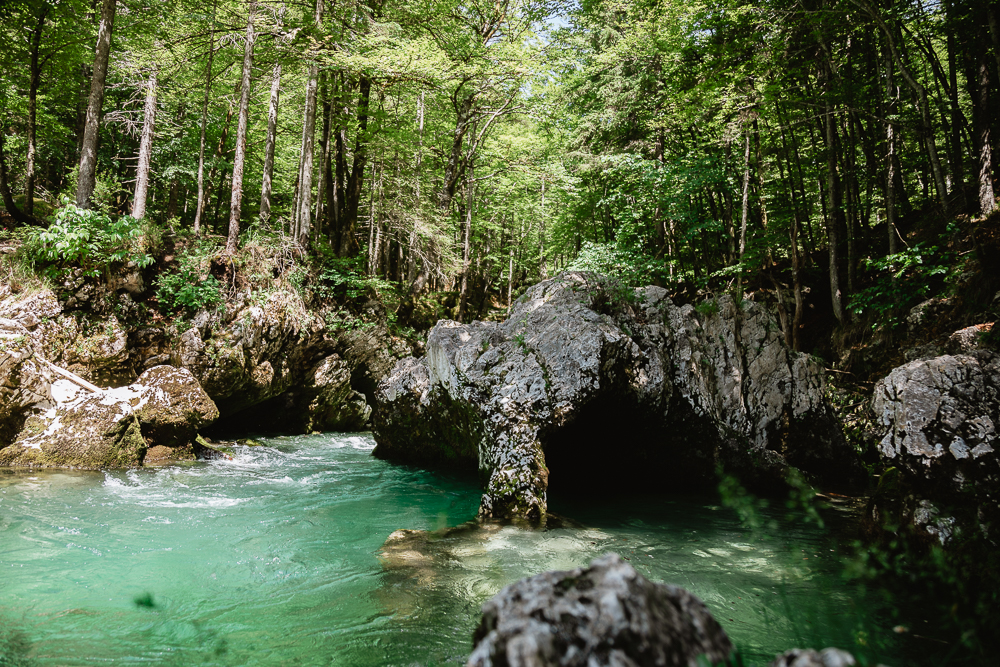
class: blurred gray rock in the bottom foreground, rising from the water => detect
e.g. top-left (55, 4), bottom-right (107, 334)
top-left (466, 554), bottom-right (733, 667)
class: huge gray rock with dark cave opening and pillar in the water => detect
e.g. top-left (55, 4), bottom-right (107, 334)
top-left (373, 273), bottom-right (858, 520)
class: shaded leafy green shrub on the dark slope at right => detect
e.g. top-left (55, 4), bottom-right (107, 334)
top-left (849, 243), bottom-right (954, 329)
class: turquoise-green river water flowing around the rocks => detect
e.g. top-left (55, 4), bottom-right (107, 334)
top-left (0, 434), bottom-right (891, 665)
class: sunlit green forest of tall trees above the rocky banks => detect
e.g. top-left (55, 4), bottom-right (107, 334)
top-left (0, 0), bottom-right (1000, 349)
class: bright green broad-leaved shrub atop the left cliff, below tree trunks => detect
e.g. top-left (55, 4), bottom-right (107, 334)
top-left (23, 197), bottom-right (159, 279)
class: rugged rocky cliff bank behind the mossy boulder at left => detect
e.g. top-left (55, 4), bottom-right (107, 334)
top-left (0, 274), bottom-right (409, 467)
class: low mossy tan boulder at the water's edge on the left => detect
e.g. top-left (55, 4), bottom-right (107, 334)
top-left (0, 366), bottom-right (219, 469)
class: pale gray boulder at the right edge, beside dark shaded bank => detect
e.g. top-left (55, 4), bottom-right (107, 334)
top-left (872, 350), bottom-right (1000, 543)
